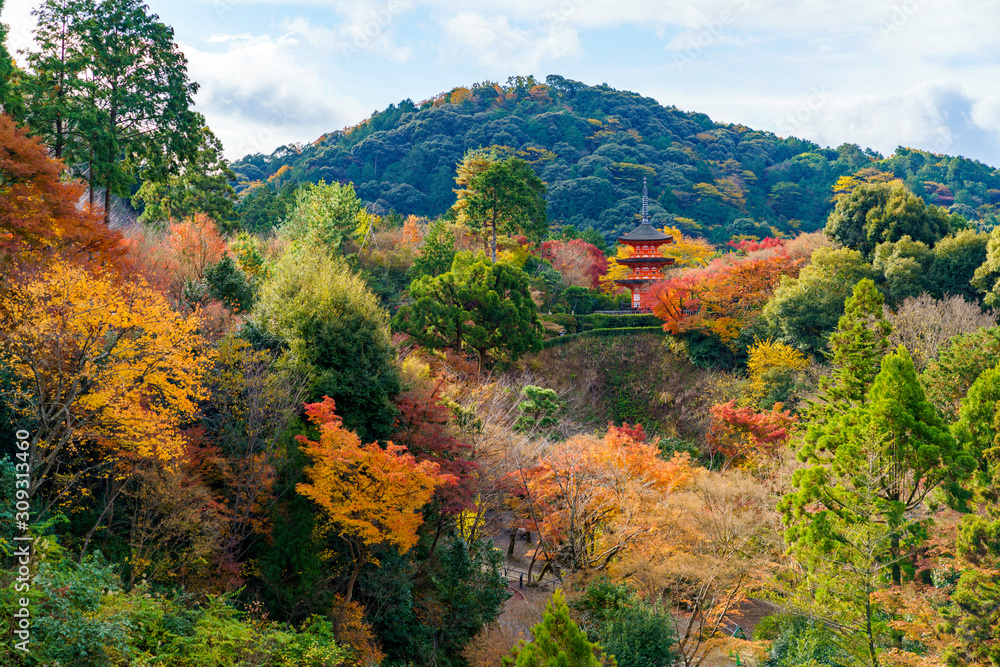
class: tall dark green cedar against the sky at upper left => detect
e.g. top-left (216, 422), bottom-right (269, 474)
top-left (22, 0), bottom-right (204, 221)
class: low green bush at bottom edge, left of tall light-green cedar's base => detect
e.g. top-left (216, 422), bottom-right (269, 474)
top-left (753, 616), bottom-right (852, 667)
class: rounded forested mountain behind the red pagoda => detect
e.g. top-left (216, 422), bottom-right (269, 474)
top-left (233, 75), bottom-right (1000, 242)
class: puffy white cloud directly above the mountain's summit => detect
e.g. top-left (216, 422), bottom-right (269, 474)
top-left (441, 12), bottom-right (582, 75)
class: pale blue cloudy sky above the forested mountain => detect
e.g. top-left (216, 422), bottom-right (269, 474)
top-left (7, 0), bottom-right (1000, 167)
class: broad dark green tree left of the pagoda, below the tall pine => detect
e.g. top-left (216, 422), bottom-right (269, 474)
top-left (393, 255), bottom-right (542, 364)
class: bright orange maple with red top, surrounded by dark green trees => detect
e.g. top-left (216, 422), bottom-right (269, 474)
top-left (296, 396), bottom-right (457, 603)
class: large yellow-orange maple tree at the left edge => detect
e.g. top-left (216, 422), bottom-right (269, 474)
top-left (0, 261), bottom-right (212, 494)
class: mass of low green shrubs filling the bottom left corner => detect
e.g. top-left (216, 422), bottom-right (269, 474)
top-left (0, 554), bottom-right (346, 667)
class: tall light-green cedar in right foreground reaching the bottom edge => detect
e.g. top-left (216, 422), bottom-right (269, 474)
top-left (779, 346), bottom-right (975, 666)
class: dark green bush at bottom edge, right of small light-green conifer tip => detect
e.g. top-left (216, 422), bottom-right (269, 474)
top-left (573, 580), bottom-right (677, 667)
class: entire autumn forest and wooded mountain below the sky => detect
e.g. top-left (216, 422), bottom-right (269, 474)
top-left (9, 0), bottom-right (1000, 667)
